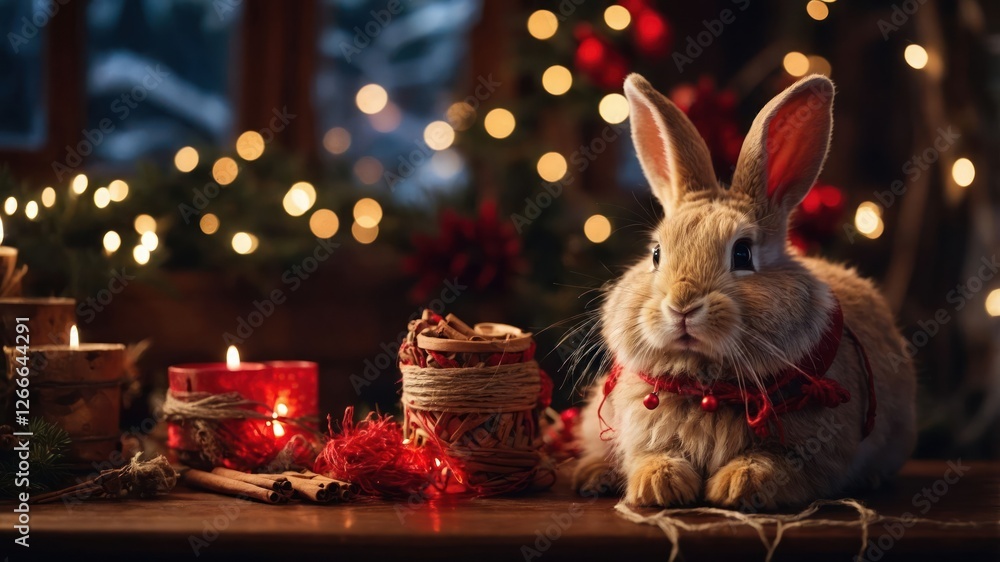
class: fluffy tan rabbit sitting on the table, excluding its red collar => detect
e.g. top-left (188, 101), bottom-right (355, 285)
top-left (573, 74), bottom-right (916, 510)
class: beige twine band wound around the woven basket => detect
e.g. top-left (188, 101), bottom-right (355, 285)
top-left (399, 361), bottom-right (541, 414)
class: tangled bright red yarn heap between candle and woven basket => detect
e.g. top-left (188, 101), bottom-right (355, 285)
top-left (313, 407), bottom-right (435, 497)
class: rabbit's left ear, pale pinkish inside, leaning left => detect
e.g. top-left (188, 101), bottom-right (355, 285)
top-left (625, 74), bottom-right (717, 216)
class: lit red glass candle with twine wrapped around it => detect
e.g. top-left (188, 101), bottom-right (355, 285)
top-left (165, 347), bottom-right (317, 470)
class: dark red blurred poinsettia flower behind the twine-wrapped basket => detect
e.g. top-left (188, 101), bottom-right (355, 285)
top-left (403, 201), bottom-right (525, 302)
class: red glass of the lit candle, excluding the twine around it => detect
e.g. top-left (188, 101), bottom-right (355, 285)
top-left (168, 347), bottom-right (318, 470)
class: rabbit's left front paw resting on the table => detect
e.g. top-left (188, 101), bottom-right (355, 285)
top-left (625, 455), bottom-right (701, 507)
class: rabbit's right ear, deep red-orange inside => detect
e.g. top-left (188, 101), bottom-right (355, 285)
top-left (732, 74), bottom-right (833, 223)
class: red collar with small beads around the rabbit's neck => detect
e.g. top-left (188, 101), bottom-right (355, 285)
top-left (598, 297), bottom-right (876, 443)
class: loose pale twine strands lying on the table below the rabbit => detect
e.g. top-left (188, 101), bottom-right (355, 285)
top-left (615, 498), bottom-right (979, 562)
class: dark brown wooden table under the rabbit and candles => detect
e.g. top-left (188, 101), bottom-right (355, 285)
top-left (0, 461), bottom-right (1000, 562)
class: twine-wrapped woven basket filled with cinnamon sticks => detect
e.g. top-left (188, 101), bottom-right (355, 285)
top-left (399, 310), bottom-right (555, 496)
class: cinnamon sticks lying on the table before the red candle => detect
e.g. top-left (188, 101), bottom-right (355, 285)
top-left (182, 467), bottom-right (357, 504)
